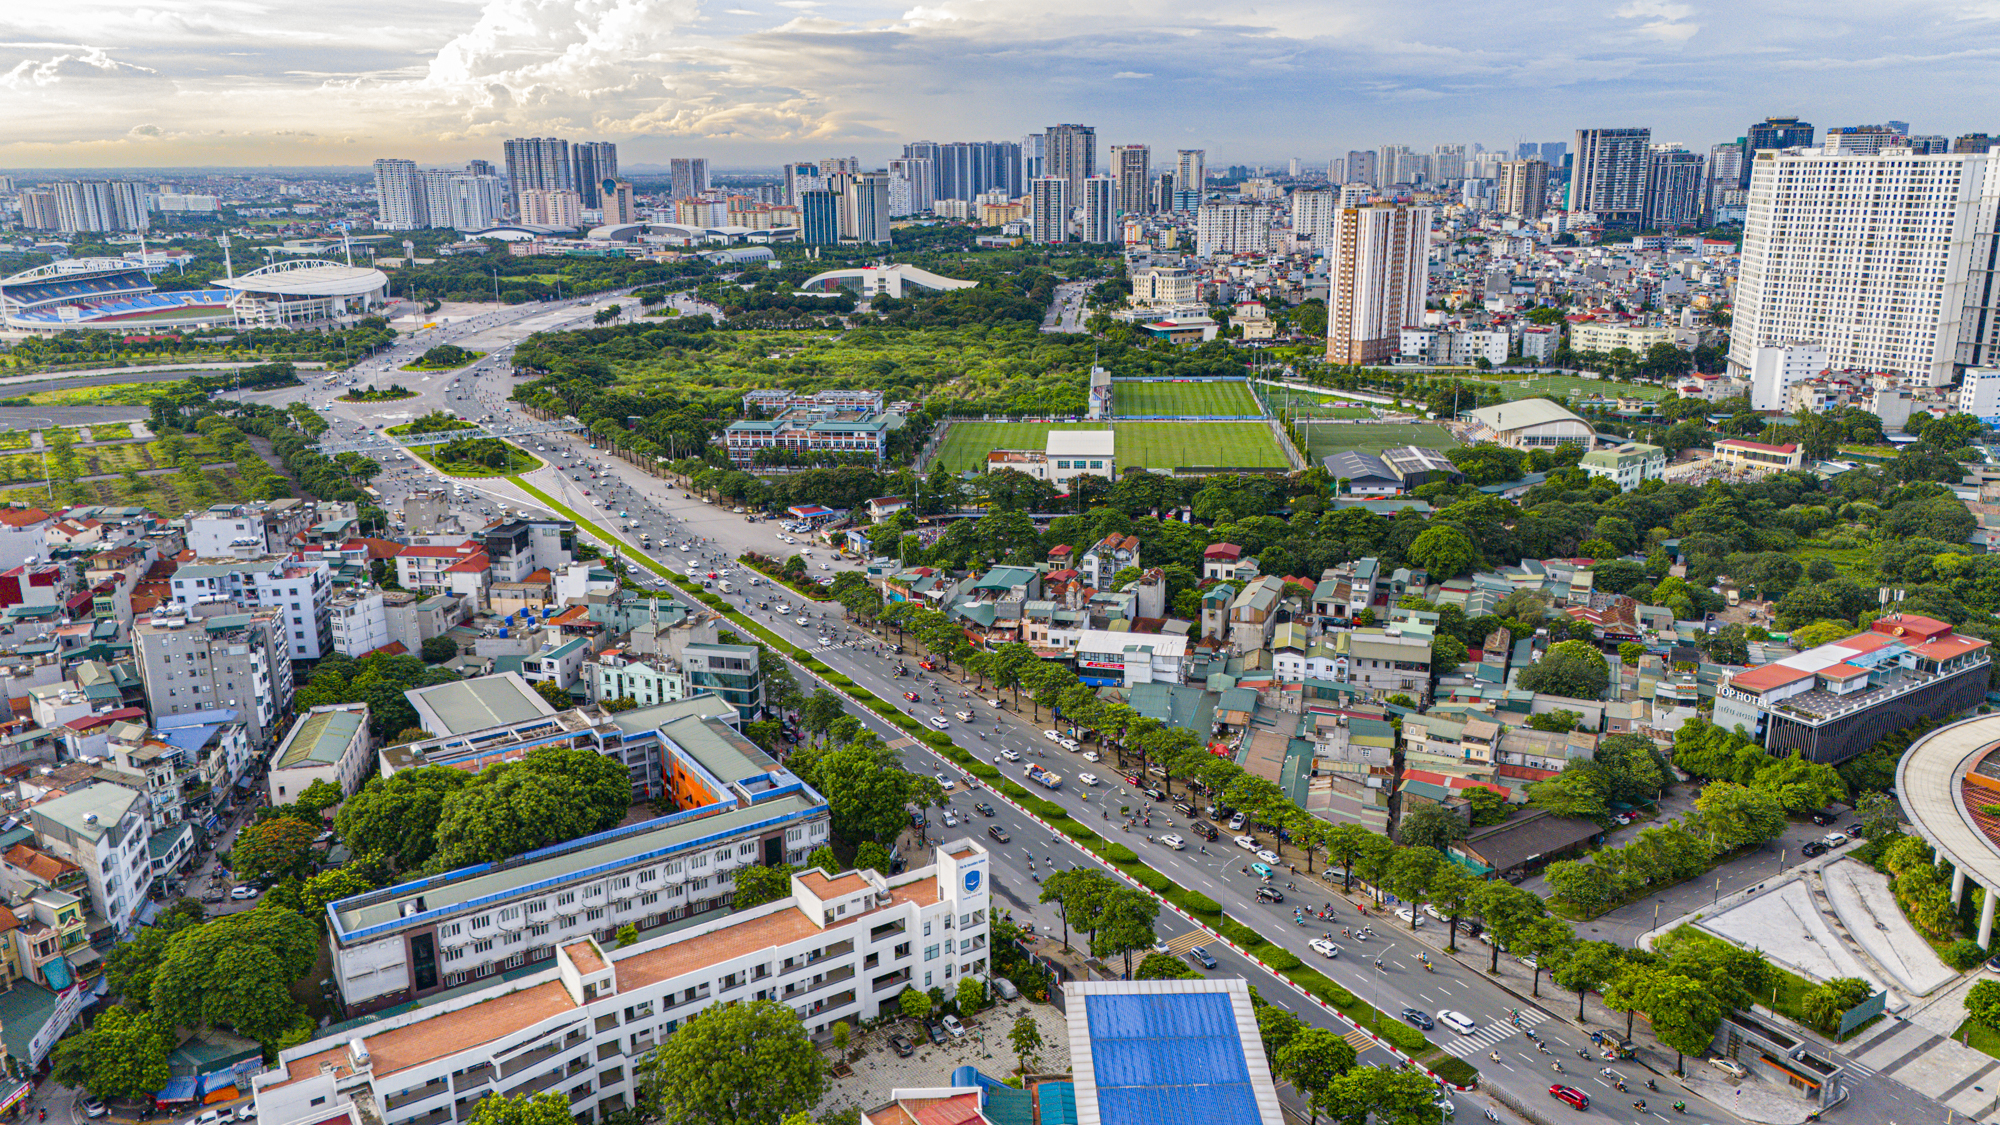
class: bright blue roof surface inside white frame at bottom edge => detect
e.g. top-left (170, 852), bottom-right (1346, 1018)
top-left (1084, 993), bottom-right (1260, 1125)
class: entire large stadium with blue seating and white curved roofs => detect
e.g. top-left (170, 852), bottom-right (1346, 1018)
top-left (0, 258), bottom-right (388, 332)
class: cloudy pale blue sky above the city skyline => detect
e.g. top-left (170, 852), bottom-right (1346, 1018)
top-left (0, 0), bottom-right (2000, 168)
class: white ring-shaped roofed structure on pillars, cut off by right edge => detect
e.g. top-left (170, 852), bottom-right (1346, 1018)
top-left (1896, 715), bottom-right (2000, 945)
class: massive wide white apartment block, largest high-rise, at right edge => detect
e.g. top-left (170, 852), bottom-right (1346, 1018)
top-left (1730, 148), bottom-right (2000, 386)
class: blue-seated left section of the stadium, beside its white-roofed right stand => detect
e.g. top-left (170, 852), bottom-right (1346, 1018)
top-left (0, 258), bottom-right (236, 332)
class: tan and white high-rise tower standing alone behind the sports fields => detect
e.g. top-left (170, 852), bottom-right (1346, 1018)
top-left (1326, 204), bottom-right (1430, 364)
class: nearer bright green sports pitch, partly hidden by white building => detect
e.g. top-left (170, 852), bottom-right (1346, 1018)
top-left (936, 422), bottom-right (1288, 472)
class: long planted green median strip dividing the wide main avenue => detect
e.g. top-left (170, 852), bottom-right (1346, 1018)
top-left (506, 474), bottom-right (1478, 1091)
